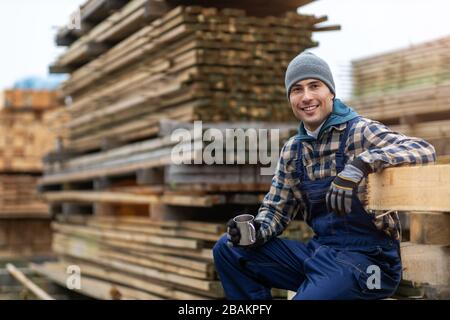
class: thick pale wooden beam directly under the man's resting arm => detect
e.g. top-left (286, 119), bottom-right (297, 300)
top-left (367, 165), bottom-right (450, 212)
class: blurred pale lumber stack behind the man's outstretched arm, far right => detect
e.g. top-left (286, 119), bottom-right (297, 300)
top-left (349, 37), bottom-right (450, 155)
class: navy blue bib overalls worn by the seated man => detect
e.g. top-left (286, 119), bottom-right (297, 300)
top-left (213, 118), bottom-right (402, 299)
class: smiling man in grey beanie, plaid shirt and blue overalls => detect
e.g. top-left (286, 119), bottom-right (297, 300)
top-left (213, 52), bottom-right (436, 299)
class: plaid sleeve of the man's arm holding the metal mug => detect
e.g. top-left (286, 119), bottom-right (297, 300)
top-left (255, 138), bottom-right (300, 242)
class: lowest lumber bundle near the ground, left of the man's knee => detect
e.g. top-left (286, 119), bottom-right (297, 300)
top-left (33, 215), bottom-right (308, 299)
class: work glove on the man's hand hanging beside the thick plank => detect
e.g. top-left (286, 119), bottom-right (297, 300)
top-left (326, 158), bottom-right (371, 215)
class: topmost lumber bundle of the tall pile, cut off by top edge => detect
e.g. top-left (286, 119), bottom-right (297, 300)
top-left (55, 0), bottom-right (320, 51)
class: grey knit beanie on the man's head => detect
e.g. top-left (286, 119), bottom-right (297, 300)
top-left (284, 51), bottom-right (336, 100)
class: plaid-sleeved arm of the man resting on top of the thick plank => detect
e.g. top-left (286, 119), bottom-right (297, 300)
top-left (355, 120), bottom-right (436, 172)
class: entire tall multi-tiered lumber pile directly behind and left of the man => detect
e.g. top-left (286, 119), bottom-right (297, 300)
top-left (33, 0), bottom-right (338, 299)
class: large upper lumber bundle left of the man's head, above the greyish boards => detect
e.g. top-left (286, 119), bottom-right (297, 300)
top-left (54, 0), bottom-right (336, 151)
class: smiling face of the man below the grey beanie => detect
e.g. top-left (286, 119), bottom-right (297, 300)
top-left (289, 79), bottom-right (334, 131)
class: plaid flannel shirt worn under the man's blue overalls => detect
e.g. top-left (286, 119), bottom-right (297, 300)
top-left (255, 118), bottom-right (436, 241)
